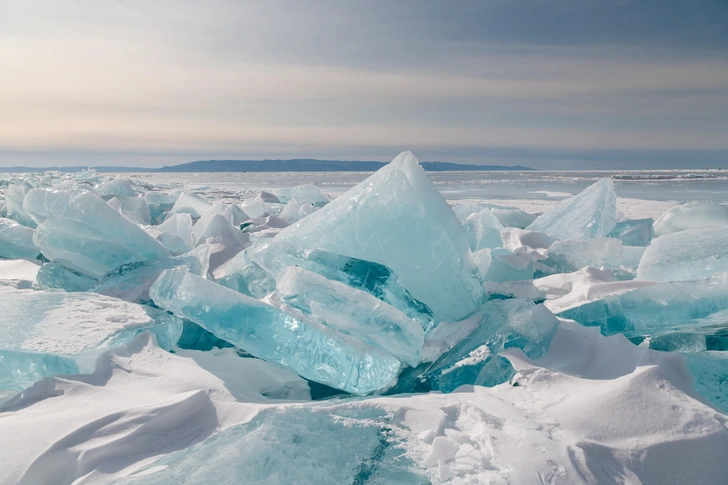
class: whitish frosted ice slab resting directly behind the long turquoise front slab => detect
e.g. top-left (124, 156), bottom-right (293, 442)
top-left (276, 267), bottom-right (424, 366)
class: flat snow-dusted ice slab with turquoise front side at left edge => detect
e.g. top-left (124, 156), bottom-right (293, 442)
top-left (0, 285), bottom-right (182, 390)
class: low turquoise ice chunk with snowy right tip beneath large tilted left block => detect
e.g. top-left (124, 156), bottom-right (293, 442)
top-left (91, 244), bottom-right (210, 303)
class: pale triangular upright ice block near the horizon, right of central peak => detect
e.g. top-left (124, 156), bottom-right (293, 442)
top-left (526, 179), bottom-right (617, 240)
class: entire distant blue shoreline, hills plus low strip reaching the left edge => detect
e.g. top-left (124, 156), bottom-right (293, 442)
top-left (0, 158), bottom-right (533, 173)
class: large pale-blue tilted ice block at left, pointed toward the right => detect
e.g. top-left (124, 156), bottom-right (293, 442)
top-left (23, 189), bottom-right (169, 278)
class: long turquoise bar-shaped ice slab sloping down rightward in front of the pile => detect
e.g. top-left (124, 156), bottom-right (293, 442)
top-left (149, 270), bottom-right (400, 394)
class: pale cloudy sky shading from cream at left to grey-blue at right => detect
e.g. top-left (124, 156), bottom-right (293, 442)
top-left (0, 0), bottom-right (728, 169)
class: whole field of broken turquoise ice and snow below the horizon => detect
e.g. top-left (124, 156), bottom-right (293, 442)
top-left (0, 154), bottom-right (728, 485)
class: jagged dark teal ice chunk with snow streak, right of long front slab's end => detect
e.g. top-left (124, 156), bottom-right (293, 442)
top-left (395, 299), bottom-right (559, 392)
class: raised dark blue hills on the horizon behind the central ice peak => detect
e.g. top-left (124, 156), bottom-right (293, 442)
top-left (159, 158), bottom-right (533, 172)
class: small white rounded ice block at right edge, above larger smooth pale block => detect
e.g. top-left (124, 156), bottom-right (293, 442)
top-left (655, 201), bottom-right (728, 236)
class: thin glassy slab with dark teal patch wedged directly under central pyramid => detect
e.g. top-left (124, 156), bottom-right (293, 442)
top-left (247, 238), bottom-right (433, 329)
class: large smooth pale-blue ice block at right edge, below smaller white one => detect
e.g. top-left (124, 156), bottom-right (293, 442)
top-left (636, 228), bottom-right (728, 281)
